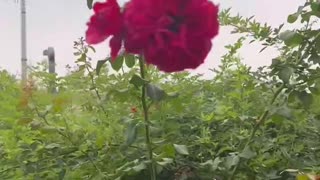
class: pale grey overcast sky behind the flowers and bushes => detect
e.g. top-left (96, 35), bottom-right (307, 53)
top-left (0, 0), bottom-right (305, 75)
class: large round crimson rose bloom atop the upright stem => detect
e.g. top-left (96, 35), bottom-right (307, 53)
top-left (123, 0), bottom-right (219, 72)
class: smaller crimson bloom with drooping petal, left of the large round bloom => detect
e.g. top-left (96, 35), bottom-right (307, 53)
top-left (86, 0), bottom-right (123, 59)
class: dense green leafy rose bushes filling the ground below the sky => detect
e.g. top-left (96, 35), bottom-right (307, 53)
top-left (0, 0), bottom-right (320, 180)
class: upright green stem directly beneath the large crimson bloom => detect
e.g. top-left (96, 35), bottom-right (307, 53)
top-left (139, 58), bottom-right (157, 180)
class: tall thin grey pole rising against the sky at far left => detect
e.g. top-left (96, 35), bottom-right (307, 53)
top-left (20, 0), bottom-right (27, 82)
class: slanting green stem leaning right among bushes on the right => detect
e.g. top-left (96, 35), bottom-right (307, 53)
top-left (228, 84), bottom-right (284, 180)
